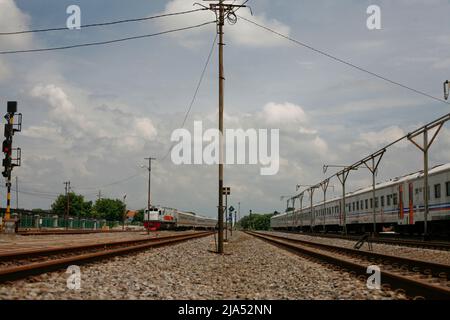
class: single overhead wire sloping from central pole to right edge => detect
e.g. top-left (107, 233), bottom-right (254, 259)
top-left (238, 15), bottom-right (450, 104)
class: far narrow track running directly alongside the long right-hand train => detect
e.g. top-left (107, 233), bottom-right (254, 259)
top-left (280, 230), bottom-right (450, 251)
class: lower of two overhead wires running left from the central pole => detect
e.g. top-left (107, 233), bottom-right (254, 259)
top-left (0, 20), bottom-right (216, 55)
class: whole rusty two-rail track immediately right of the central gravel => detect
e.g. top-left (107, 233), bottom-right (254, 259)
top-left (247, 232), bottom-right (450, 300)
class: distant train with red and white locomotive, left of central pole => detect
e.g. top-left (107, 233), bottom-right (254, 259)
top-left (144, 207), bottom-right (217, 231)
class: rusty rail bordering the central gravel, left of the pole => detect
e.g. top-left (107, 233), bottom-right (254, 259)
top-left (0, 232), bottom-right (213, 283)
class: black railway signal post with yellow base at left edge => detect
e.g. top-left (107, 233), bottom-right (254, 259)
top-left (2, 101), bottom-right (22, 233)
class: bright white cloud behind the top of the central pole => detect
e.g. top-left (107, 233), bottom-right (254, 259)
top-left (158, 0), bottom-right (290, 48)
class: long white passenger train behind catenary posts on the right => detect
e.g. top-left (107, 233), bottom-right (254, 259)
top-left (271, 163), bottom-right (450, 237)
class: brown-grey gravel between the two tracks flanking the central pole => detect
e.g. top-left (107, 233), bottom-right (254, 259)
top-left (0, 232), bottom-right (402, 300)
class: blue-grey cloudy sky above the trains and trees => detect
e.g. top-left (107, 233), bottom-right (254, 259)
top-left (0, 0), bottom-right (450, 216)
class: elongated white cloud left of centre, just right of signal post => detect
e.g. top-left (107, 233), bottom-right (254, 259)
top-left (26, 84), bottom-right (157, 157)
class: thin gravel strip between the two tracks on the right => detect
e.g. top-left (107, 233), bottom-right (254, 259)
top-left (268, 232), bottom-right (450, 265)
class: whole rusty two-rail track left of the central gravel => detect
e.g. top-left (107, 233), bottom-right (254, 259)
top-left (0, 231), bottom-right (213, 283)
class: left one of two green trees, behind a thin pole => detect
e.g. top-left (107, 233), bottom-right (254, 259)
top-left (51, 192), bottom-right (92, 218)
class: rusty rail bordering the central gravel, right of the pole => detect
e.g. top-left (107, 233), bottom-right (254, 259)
top-left (247, 232), bottom-right (450, 300)
